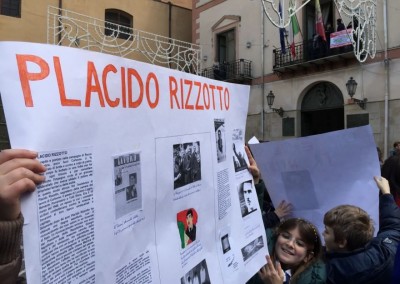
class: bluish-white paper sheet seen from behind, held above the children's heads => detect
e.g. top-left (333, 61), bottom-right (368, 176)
top-left (250, 126), bottom-right (380, 240)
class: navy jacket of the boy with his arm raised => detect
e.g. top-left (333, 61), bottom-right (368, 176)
top-left (326, 194), bottom-right (400, 284)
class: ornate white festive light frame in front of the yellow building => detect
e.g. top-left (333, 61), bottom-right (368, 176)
top-left (47, 6), bottom-right (201, 74)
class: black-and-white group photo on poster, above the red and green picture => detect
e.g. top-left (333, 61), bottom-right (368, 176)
top-left (173, 141), bottom-right (201, 189)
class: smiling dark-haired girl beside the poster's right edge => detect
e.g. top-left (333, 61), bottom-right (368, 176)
top-left (255, 218), bottom-right (326, 284)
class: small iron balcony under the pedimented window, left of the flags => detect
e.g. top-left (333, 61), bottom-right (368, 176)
top-left (201, 59), bottom-right (252, 84)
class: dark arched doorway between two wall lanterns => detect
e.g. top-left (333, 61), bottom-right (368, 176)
top-left (301, 82), bottom-right (344, 136)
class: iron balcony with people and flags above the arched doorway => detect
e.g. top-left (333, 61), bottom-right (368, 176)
top-left (273, 40), bottom-right (355, 74)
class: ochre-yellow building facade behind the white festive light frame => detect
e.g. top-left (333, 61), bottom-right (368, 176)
top-left (0, 0), bottom-right (196, 149)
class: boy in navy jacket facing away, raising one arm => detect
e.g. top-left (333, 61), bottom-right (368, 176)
top-left (323, 177), bottom-right (400, 284)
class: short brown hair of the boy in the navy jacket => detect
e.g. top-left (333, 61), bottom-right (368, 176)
top-left (324, 205), bottom-right (374, 251)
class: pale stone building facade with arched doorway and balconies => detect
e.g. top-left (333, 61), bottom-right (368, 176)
top-left (192, 0), bottom-right (400, 156)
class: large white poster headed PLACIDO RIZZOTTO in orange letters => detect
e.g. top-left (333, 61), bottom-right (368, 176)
top-left (0, 42), bottom-right (267, 284)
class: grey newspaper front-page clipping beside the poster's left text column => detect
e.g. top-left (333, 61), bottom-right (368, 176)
top-left (113, 153), bottom-right (142, 219)
